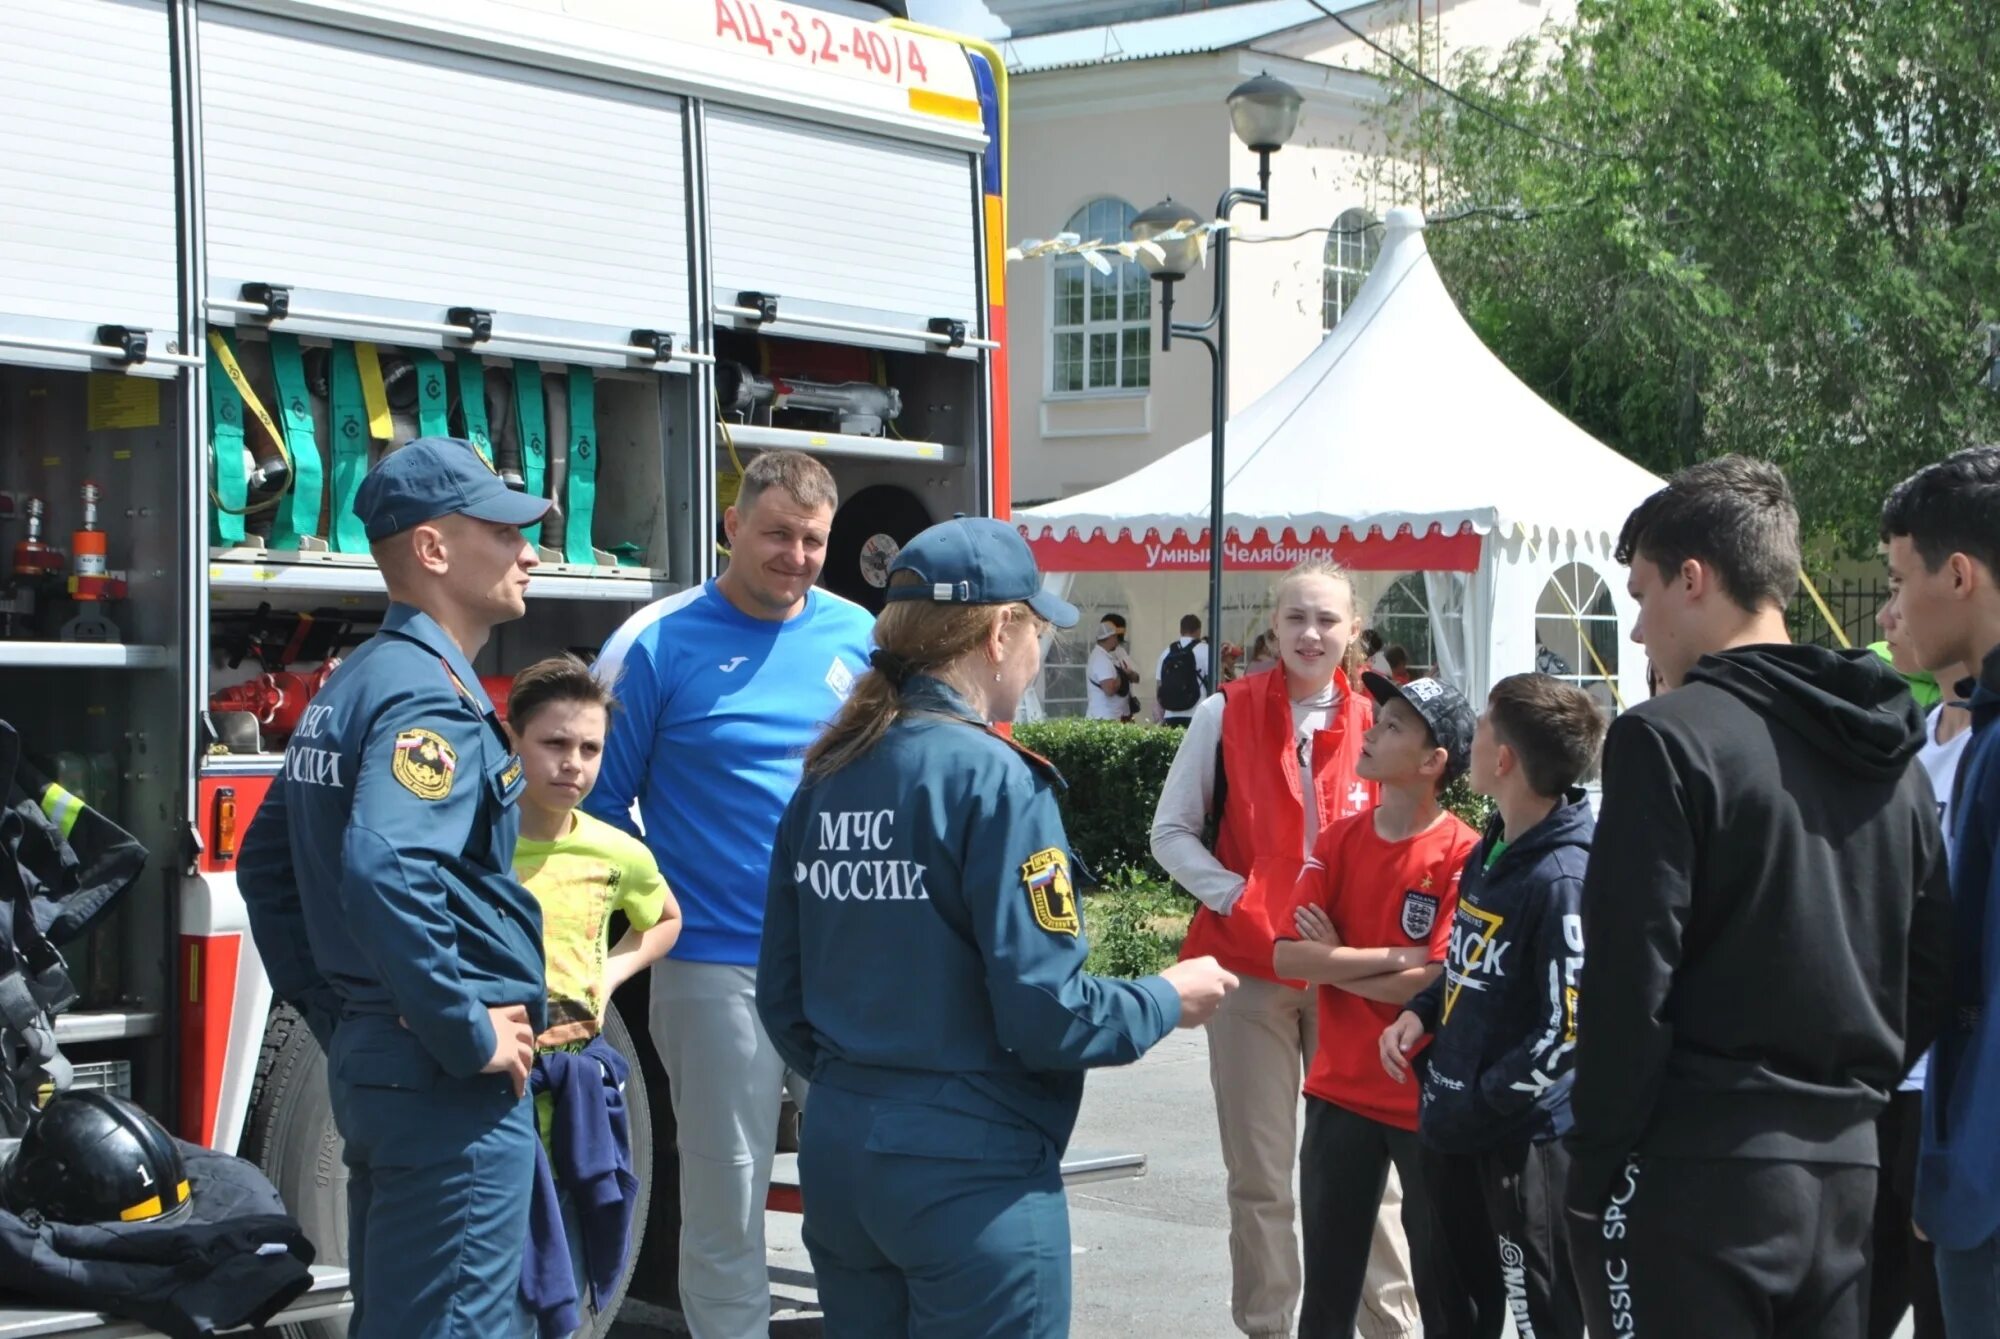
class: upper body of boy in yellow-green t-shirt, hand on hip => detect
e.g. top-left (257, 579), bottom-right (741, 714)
top-left (508, 656), bottom-right (680, 1051)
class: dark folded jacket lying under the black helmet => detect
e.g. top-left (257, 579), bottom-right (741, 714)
top-left (0, 1143), bottom-right (312, 1339)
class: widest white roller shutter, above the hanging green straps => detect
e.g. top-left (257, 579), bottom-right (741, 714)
top-left (202, 6), bottom-right (690, 336)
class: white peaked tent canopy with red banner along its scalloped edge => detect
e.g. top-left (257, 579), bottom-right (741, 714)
top-left (1016, 210), bottom-right (1660, 572)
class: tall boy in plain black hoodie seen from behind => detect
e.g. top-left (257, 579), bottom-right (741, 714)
top-left (1568, 456), bottom-right (1950, 1339)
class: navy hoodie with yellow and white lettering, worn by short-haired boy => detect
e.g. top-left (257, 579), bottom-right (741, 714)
top-left (1408, 789), bottom-right (1594, 1153)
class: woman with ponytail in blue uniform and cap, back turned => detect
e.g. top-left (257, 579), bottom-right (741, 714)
top-left (758, 520), bottom-right (1236, 1339)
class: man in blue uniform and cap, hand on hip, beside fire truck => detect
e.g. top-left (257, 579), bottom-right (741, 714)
top-left (238, 438), bottom-right (548, 1339)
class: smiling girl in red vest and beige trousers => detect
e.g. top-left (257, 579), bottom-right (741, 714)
top-left (1152, 564), bottom-right (1418, 1339)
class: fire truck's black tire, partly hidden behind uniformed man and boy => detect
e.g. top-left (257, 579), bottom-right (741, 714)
top-left (238, 1005), bottom-right (652, 1339)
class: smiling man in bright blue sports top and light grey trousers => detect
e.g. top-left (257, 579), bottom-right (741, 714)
top-left (584, 452), bottom-right (874, 1339)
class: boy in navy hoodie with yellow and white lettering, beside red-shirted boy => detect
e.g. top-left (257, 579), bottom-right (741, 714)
top-left (1380, 673), bottom-right (1604, 1339)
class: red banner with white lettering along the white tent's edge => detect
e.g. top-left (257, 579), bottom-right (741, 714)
top-left (1020, 526), bottom-right (1480, 572)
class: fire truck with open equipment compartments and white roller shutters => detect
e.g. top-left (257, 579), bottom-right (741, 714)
top-left (0, 0), bottom-right (1008, 1335)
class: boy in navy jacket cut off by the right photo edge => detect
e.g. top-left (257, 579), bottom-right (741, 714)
top-left (1882, 446), bottom-right (2000, 1339)
